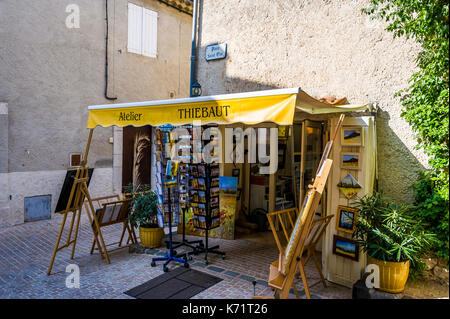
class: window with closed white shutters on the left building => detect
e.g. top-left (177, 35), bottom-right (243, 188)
top-left (128, 3), bottom-right (158, 58)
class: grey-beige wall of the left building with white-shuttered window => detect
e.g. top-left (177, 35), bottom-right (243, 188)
top-left (0, 0), bottom-right (192, 228)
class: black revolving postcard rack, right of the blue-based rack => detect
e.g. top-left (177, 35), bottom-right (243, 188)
top-left (189, 164), bottom-right (225, 264)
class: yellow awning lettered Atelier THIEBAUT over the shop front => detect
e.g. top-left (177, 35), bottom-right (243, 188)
top-left (87, 88), bottom-right (367, 128)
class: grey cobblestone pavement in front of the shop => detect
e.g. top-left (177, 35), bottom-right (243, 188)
top-left (0, 216), bottom-right (351, 299)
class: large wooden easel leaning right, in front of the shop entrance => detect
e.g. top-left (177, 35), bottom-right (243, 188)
top-left (254, 115), bottom-right (344, 299)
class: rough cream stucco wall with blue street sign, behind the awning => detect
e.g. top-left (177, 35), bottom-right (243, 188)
top-left (197, 0), bottom-right (426, 202)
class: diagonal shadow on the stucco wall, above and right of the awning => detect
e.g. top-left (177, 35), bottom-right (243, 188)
top-left (193, 43), bottom-right (425, 204)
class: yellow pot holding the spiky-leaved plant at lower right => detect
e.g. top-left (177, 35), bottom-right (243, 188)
top-left (368, 257), bottom-right (409, 293)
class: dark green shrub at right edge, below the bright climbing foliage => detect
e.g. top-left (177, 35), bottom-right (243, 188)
top-left (413, 174), bottom-right (449, 262)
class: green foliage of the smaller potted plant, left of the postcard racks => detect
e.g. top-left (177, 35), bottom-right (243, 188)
top-left (126, 184), bottom-right (158, 228)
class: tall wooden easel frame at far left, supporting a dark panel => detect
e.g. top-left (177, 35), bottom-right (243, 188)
top-left (47, 129), bottom-right (110, 275)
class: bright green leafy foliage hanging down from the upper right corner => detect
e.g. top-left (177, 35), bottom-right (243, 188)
top-left (363, 0), bottom-right (449, 201)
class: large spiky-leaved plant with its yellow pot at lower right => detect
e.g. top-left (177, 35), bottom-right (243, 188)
top-left (354, 194), bottom-right (435, 293)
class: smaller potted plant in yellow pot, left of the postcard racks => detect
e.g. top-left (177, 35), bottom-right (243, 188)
top-left (128, 185), bottom-right (164, 248)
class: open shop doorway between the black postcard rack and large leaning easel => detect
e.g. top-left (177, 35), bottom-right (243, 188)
top-left (236, 119), bottom-right (327, 242)
